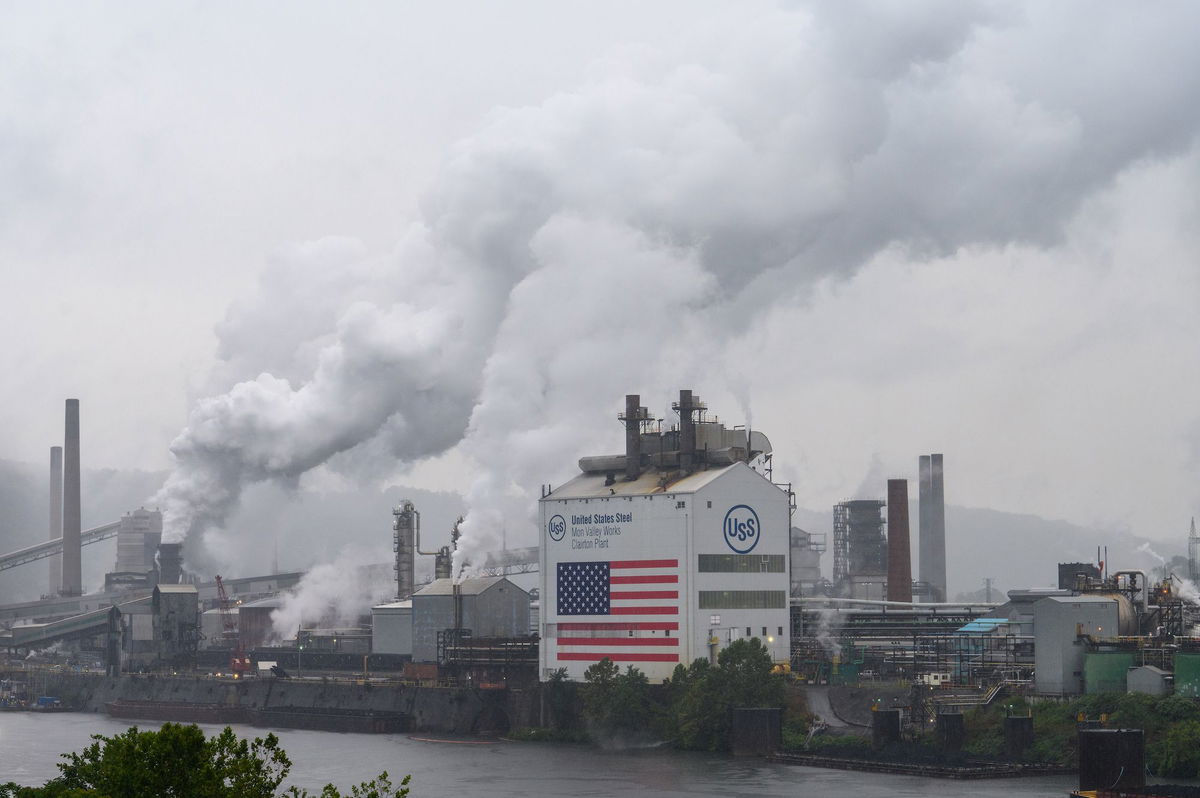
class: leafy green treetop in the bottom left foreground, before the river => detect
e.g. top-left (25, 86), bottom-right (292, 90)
top-left (0, 724), bottom-right (408, 798)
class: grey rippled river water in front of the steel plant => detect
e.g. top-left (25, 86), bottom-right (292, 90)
top-left (0, 712), bottom-right (1074, 798)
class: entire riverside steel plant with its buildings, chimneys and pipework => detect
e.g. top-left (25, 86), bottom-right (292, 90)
top-left (0, 390), bottom-right (1200, 728)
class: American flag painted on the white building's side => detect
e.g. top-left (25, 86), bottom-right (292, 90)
top-left (554, 559), bottom-right (679, 662)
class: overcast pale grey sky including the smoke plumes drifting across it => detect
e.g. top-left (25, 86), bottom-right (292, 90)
top-left (0, 0), bottom-right (1200, 573)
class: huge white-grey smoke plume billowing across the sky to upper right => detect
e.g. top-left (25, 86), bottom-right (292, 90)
top-left (152, 2), bottom-right (1200, 576)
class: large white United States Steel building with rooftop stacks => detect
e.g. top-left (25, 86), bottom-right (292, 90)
top-left (539, 391), bottom-right (791, 682)
